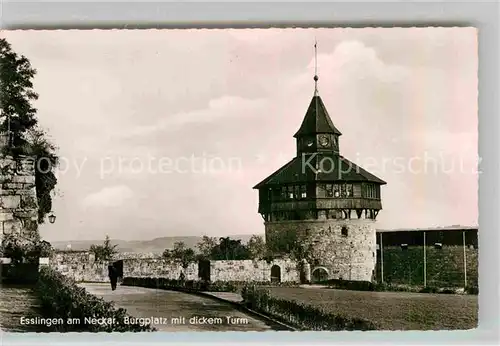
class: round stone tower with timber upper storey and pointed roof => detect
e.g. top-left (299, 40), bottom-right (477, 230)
top-left (254, 62), bottom-right (386, 281)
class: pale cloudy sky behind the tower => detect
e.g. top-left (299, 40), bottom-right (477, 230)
top-left (3, 28), bottom-right (478, 240)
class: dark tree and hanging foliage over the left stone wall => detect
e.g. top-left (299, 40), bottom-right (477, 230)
top-left (0, 38), bottom-right (58, 223)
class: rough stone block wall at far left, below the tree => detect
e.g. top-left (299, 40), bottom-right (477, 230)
top-left (0, 156), bottom-right (38, 245)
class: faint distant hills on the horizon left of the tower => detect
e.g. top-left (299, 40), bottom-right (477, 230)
top-left (50, 234), bottom-right (263, 253)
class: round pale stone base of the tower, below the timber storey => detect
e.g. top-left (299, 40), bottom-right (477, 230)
top-left (265, 219), bottom-right (376, 281)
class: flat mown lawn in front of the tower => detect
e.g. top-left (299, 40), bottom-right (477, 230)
top-left (269, 287), bottom-right (478, 330)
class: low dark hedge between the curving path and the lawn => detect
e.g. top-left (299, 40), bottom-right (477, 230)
top-left (242, 286), bottom-right (377, 331)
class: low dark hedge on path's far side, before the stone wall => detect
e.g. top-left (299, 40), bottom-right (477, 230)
top-left (122, 277), bottom-right (297, 292)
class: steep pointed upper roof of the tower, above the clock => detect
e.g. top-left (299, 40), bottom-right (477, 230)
top-left (294, 95), bottom-right (342, 138)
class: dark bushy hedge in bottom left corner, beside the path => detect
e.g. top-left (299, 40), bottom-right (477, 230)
top-left (34, 267), bottom-right (155, 332)
